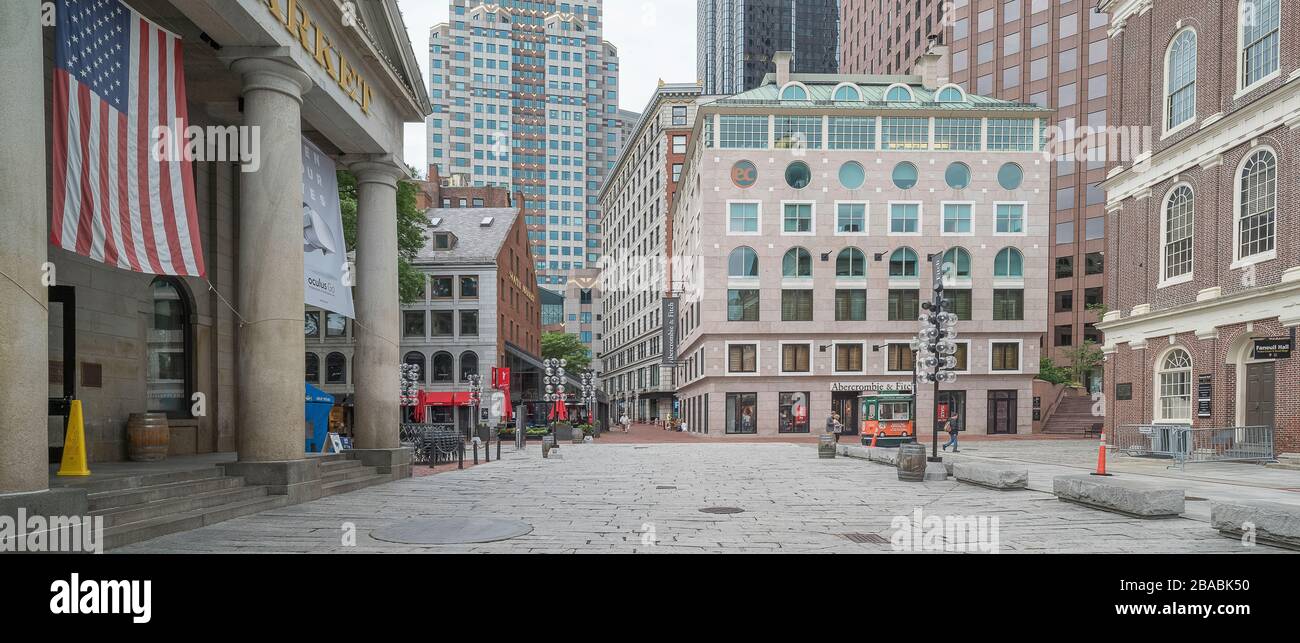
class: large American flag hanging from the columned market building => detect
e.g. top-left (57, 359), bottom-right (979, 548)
top-left (49, 0), bottom-right (205, 277)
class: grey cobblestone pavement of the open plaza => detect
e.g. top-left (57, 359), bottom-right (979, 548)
top-left (116, 443), bottom-right (1278, 553)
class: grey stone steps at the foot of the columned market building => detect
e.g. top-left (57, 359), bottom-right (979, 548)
top-left (77, 453), bottom-right (393, 549)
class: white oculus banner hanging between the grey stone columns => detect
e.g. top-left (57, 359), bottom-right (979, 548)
top-left (303, 136), bottom-right (356, 320)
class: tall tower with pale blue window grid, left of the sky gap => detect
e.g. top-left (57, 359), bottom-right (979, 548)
top-left (428, 0), bottom-right (621, 290)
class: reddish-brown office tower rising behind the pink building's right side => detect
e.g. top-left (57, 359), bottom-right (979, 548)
top-left (841, 0), bottom-right (1109, 390)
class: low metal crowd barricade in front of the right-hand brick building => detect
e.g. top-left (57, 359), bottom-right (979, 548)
top-left (1106, 425), bottom-right (1274, 469)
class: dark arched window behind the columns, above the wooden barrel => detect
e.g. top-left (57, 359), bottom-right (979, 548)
top-left (144, 277), bottom-right (192, 418)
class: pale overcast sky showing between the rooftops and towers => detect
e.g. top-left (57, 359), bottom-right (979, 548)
top-left (398, 0), bottom-right (697, 174)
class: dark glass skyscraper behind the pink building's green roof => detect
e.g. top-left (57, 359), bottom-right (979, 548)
top-left (696, 0), bottom-right (841, 95)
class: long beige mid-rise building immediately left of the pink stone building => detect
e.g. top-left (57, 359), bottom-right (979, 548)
top-left (597, 83), bottom-right (705, 420)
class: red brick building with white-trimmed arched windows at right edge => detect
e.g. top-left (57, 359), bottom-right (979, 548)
top-left (1101, 0), bottom-right (1300, 452)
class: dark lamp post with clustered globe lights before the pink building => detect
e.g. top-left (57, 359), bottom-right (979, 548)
top-left (911, 252), bottom-right (957, 462)
